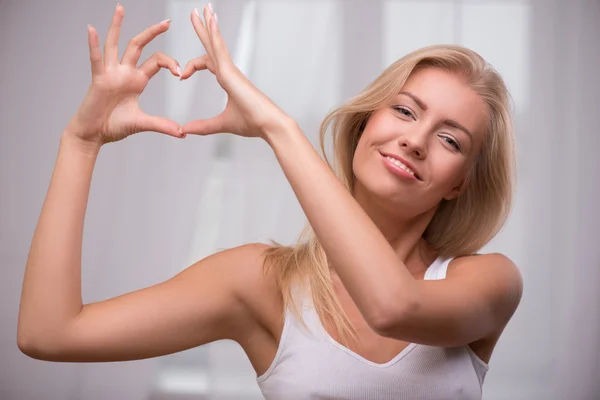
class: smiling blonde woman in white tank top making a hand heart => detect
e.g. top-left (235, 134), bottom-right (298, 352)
top-left (18, 5), bottom-right (522, 400)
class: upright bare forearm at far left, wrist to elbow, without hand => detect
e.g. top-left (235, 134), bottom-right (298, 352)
top-left (18, 133), bottom-right (100, 345)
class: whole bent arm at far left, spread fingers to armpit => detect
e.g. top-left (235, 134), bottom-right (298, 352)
top-left (17, 6), bottom-right (264, 361)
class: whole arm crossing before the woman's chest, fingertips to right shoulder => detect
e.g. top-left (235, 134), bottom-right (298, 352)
top-left (177, 8), bottom-right (522, 346)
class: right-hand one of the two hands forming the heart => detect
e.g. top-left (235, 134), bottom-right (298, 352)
top-left (181, 3), bottom-right (291, 138)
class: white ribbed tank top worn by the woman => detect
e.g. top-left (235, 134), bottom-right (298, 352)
top-left (257, 258), bottom-right (488, 400)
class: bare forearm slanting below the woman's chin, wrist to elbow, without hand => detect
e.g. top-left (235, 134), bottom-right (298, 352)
top-left (266, 124), bottom-right (416, 325)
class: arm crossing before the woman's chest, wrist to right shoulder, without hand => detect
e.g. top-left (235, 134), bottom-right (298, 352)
top-left (267, 124), bottom-right (522, 346)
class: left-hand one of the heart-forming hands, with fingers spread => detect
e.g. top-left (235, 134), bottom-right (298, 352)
top-left (63, 4), bottom-right (185, 146)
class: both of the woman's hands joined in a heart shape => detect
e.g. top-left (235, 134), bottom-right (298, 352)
top-left (75, 3), bottom-right (290, 144)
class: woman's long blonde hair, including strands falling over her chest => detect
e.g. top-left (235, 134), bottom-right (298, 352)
top-left (264, 45), bottom-right (515, 343)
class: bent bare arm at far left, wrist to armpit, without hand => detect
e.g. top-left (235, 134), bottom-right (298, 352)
top-left (18, 132), bottom-right (264, 362)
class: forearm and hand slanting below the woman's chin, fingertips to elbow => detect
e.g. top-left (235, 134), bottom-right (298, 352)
top-left (182, 8), bottom-right (417, 329)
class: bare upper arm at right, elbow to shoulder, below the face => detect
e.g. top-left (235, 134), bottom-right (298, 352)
top-left (380, 253), bottom-right (523, 347)
